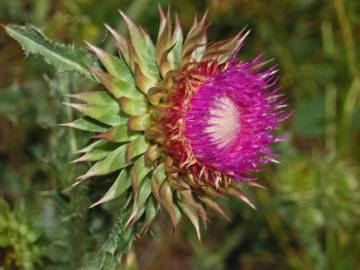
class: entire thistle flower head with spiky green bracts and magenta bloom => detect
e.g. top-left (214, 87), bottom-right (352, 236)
top-left (66, 6), bottom-right (288, 237)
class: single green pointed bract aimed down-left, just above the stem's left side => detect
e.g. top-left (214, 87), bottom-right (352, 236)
top-left (91, 169), bottom-right (131, 207)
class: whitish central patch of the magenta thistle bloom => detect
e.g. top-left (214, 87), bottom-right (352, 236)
top-left (205, 96), bottom-right (241, 148)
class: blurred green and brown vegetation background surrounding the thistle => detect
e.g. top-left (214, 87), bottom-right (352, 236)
top-left (0, 0), bottom-right (360, 270)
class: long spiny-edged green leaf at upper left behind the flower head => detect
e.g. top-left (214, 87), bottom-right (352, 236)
top-left (3, 24), bottom-right (97, 81)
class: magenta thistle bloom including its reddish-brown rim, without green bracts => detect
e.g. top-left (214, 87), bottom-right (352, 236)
top-left (162, 57), bottom-right (287, 187)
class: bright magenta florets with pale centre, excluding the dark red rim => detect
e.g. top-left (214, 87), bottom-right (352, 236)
top-left (184, 58), bottom-right (288, 180)
